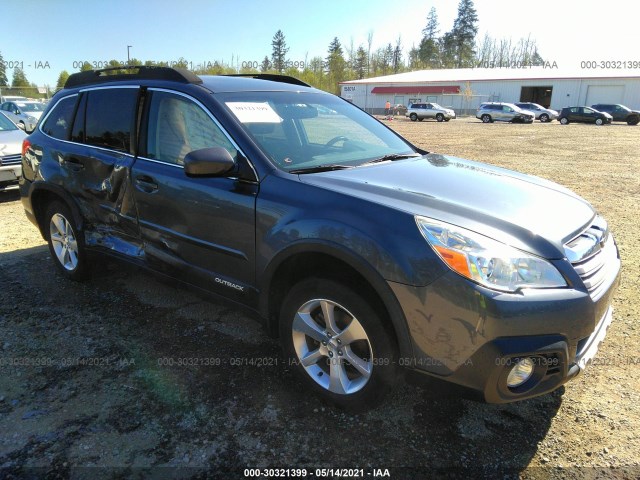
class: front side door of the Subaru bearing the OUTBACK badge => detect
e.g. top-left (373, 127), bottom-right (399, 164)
top-left (132, 89), bottom-right (258, 303)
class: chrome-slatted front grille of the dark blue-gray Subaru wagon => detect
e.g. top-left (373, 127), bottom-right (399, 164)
top-left (565, 219), bottom-right (620, 301)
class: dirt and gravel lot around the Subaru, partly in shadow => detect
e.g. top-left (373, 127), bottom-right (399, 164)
top-left (0, 119), bottom-right (640, 479)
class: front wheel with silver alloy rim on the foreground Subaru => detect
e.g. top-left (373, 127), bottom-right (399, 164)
top-left (280, 278), bottom-right (398, 412)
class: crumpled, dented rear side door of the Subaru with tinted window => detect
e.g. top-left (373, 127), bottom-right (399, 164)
top-left (43, 86), bottom-right (139, 248)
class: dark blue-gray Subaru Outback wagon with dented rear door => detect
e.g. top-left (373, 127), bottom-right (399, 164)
top-left (20, 67), bottom-right (620, 409)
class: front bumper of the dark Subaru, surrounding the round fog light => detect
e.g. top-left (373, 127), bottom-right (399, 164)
top-left (390, 253), bottom-right (620, 403)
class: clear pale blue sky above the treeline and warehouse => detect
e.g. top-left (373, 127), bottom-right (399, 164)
top-left (0, 0), bottom-right (640, 87)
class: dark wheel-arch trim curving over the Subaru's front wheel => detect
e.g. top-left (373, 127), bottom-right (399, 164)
top-left (259, 238), bottom-right (413, 358)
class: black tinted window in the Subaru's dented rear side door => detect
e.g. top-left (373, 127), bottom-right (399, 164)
top-left (85, 88), bottom-right (138, 152)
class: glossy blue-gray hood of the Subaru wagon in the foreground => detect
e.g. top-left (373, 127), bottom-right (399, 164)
top-left (300, 154), bottom-right (595, 258)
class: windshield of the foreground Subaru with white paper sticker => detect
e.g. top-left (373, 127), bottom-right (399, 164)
top-left (216, 92), bottom-right (417, 171)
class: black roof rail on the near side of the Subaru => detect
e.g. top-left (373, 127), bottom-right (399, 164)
top-left (64, 65), bottom-right (202, 88)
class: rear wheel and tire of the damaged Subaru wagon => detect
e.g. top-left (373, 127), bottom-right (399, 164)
top-left (43, 201), bottom-right (89, 280)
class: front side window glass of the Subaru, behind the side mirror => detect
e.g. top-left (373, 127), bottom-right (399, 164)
top-left (145, 91), bottom-right (238, 165)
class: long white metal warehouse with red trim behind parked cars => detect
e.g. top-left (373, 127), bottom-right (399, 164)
top-left (340, 67), bottom-right (640, 114)
